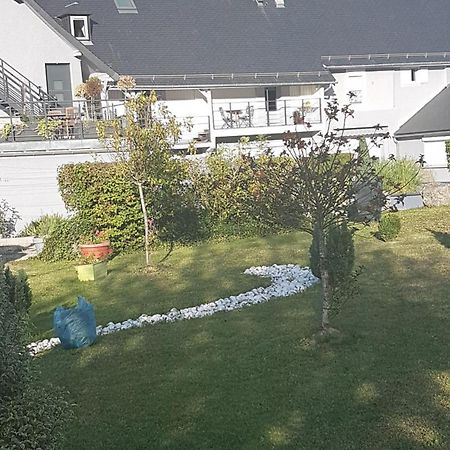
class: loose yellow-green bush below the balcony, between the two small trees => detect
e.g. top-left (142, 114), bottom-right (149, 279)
top-left (191, 152), bottom-right (295, 236)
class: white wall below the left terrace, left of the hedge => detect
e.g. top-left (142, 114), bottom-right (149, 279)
top-left (0, 153), bottom-right (111, 231)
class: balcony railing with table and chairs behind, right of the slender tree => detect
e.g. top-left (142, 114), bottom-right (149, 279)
top-left (213, 98), bottom-right (322, 130)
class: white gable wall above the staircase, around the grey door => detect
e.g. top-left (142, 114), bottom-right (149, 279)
top-left (0, 0), bottom-right (83, 92)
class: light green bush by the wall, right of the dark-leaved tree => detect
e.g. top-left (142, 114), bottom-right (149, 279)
top-left (374, 159), bottom-right (422, 195)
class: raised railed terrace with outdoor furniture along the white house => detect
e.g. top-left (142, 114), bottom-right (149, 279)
top-left (0, 97), bottom-right (322, 155)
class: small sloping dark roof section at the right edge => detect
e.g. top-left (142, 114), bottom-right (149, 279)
top-left (395, 85), bottom-right (450, 139)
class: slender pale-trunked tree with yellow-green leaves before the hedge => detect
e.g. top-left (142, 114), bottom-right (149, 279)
top-left (97, 84), bottom-right (190, 267)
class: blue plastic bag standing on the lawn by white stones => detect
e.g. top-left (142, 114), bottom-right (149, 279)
top-left (53, 296), bottom-right (97, 349)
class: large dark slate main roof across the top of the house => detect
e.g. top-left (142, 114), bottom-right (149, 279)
top-left (29, 0), bottom-right (450, 84)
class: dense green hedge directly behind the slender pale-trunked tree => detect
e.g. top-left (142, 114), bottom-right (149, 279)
top-left (57, 159), bottom-right (205, 255)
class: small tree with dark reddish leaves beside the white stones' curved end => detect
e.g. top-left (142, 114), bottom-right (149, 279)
top-left (264, 96), bottom-right (422, 334)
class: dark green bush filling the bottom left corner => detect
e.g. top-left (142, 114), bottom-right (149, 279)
top-left (0, 267), bottom-right (72, 450)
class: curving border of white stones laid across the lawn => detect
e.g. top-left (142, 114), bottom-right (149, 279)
top-left (27, 264), bottom-right (319, 355)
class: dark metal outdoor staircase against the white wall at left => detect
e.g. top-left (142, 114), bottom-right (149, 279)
top-left (0, 58), bottom-right (57, 116)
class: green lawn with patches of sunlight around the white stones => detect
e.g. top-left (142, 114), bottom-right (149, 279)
top-left (12, 208), bottom-right (450, 450)
